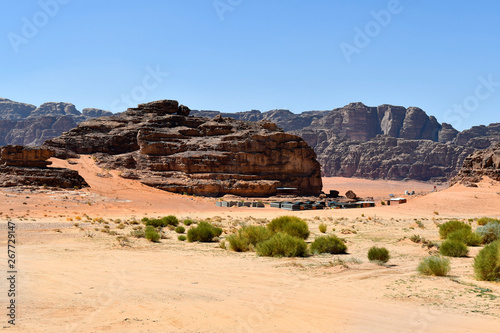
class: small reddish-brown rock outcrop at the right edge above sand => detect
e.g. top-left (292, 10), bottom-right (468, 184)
top-left (451, 143), bottom-right (500, 186)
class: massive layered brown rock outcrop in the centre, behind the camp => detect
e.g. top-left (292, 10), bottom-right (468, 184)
top-left (44, 100), bottom-right (322, 197)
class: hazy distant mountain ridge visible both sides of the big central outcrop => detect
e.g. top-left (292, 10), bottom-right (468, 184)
top-left (0, 98), bottom-right (500, 181)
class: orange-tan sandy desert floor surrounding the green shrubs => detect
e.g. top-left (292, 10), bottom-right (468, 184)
top-left (0, 157), bottom-right (500, 332)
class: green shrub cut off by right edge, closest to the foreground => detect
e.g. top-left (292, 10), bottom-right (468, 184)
top-left (474, 240), bottom-right (500, 281)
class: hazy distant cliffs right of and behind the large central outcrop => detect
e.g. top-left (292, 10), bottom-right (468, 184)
top-left (193, 103), bottom-right (500, 181)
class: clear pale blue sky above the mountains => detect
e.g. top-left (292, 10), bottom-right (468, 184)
top-left (0, 0), bottom-right (500, 129)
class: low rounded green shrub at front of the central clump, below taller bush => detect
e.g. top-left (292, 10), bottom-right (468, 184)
top-left (256, 232), bottom-right (307, 257)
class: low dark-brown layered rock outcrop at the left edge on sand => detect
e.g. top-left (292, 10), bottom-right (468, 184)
top-left (0, 146), bottom-right (88, 188)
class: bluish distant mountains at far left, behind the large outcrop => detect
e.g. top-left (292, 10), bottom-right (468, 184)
top-left (0, 98), bottom-right (112, 146)
